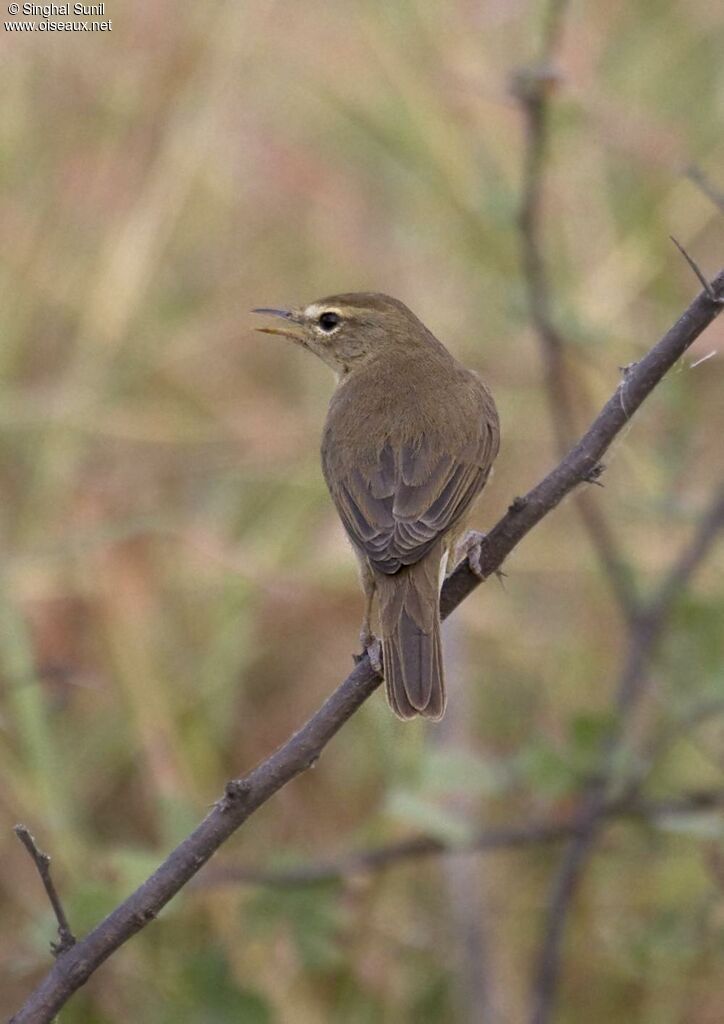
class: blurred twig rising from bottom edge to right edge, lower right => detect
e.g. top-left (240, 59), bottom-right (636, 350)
top-left (531, 479), bottom-right (724, 1024)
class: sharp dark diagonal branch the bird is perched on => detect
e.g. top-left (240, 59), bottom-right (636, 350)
top-left (12, 270), bottom-right (724, 1024)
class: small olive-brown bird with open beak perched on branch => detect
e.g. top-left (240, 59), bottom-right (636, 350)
top-left (253, 292), bottom-right (500, 719)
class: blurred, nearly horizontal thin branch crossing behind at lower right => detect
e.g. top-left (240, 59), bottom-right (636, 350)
top-left (198, 790), bottom-right (724, 889)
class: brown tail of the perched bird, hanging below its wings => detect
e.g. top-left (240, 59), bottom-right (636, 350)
top-left (378, 552), bottom-right (445, 719)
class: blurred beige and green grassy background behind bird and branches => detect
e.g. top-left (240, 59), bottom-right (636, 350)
top-left (0, 0), bottom-right (724, 1024)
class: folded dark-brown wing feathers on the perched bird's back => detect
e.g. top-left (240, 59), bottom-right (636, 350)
top-left (328, 425), bottom-right (497, 574)
